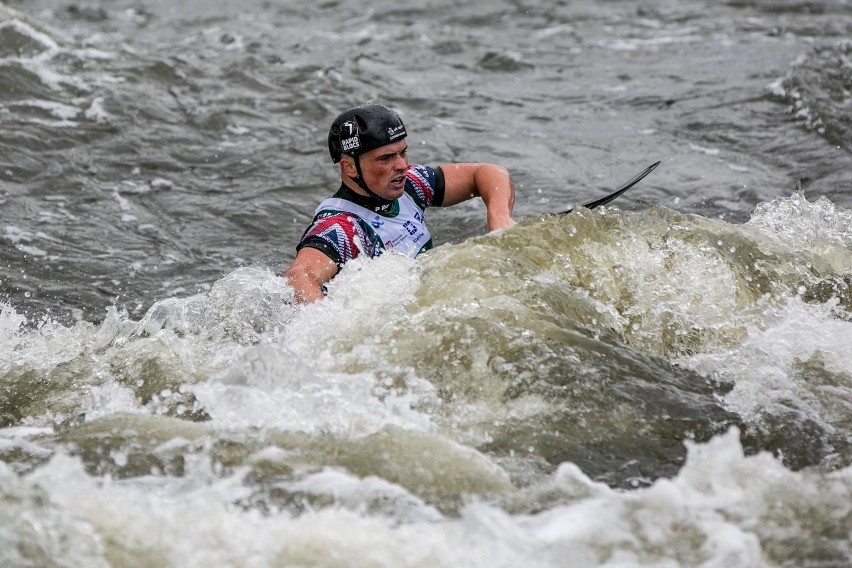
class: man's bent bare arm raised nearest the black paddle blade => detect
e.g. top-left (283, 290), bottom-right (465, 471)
top-left (441, 164), bottom-right (515, 231)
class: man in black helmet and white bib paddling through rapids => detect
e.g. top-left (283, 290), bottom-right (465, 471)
top-left (284, 104), bottom-right (515, 303)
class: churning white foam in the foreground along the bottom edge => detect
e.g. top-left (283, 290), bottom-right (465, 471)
top-left (5, 430), bottom-right (852, 568)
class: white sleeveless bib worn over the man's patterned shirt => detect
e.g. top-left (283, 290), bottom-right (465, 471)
top-left (314, 192), bottom-right (432, 257)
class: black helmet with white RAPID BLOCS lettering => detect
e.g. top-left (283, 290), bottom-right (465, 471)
top-left (328, 104), bottom-right (406, 164)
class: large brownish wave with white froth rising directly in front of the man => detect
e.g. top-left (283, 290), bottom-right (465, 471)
top-left (0, 194), bottom-right (852, 486)
